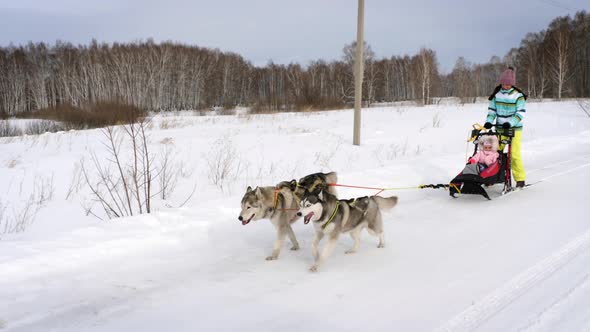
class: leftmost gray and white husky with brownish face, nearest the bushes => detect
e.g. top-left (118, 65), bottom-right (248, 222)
top-left (238, 187), bottom-right (299, 260)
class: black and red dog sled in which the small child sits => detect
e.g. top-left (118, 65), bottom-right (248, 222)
top-left (449, 125), bottom-right (514, 199)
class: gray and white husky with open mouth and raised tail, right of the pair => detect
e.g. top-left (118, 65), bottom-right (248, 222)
top-left (299, 191), bottom-right (397, 272)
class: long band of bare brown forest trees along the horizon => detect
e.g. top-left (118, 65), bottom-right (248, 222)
top-left (0, 11), bottom-right (590, 116)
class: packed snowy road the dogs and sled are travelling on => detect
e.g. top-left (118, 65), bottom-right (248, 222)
top-left (0, 102), bottom-right (590, 332)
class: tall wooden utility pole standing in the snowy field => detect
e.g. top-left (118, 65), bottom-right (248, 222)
top-left (352, 0), bottom-right (365, 145)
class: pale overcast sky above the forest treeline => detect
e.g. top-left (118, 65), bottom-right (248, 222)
top-left (0, 0), bottom-right (590, 72)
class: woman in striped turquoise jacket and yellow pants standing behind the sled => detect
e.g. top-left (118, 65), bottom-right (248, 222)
top-left (484, 67), bottom-right (526, 188)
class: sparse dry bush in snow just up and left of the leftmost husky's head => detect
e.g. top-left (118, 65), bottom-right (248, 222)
top-left (206, 139), bottom-right (241, 190)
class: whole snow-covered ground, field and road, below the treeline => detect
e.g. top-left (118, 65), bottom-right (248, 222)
top-left (0, 102), bottom-right (590, 331)
